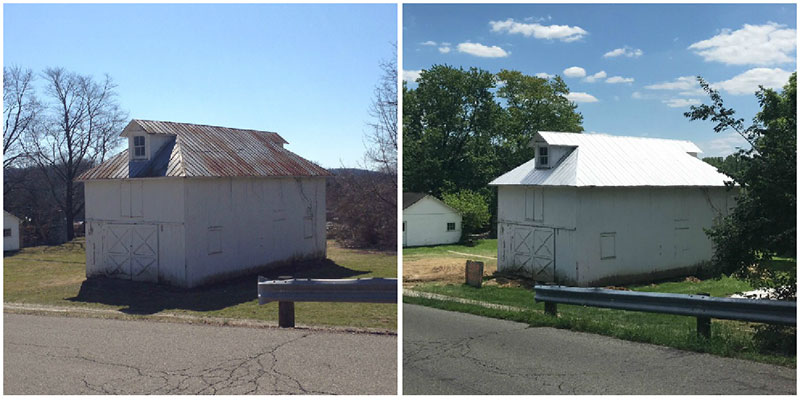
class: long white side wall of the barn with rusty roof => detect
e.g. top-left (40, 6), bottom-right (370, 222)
top-left (185, 178), bottom-right (326, 287)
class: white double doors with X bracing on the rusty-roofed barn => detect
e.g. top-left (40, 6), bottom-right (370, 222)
top-left (103, 224), bottom-right (158, 282)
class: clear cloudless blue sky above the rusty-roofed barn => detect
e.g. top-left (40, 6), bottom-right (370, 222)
top-left (3, 4), bottom-right (397, 168)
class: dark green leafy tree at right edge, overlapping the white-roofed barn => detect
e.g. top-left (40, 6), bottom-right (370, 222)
top-left (684, 73), bottom-right (797, 298)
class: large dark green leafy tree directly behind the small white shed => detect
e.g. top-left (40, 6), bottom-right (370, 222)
top-left (403, 65), bottom-right (502, 197)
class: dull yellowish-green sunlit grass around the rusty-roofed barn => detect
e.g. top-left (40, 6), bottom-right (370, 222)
top-left (3, 239), bottom-right (397, 330)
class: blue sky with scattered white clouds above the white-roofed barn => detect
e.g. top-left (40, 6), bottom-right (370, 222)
top-left (403, 4), bottom-right (797, 156)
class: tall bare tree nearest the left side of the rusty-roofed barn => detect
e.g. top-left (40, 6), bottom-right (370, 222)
top-left (23, 68), bottom-right (127, 240)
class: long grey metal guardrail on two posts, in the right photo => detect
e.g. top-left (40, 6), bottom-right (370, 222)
top-left (534, 285), bottom-right (797, 337)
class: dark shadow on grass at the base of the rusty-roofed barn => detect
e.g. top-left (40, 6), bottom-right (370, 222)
top-left (66, 259), bottom-right (370, 314)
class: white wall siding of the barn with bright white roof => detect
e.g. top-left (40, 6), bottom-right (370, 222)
top-left (498, 186), bottom-right (735, 286)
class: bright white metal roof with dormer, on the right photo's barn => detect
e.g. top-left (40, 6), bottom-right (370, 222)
top-left (489, 132), bottom-right (730, 187)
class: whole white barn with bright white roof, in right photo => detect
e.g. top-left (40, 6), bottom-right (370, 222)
top-left (490, 132), bottom-right (738, 286)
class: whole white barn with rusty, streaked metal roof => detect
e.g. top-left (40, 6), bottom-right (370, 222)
top-left (78, 120), bottom-right (330, 288)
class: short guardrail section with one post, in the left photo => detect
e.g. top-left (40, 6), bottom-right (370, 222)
top-left (258, 276), bottom-right (397, 328)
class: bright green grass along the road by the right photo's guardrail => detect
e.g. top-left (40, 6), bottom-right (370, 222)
top-left (410, 241), bottom-right (797, 367)
